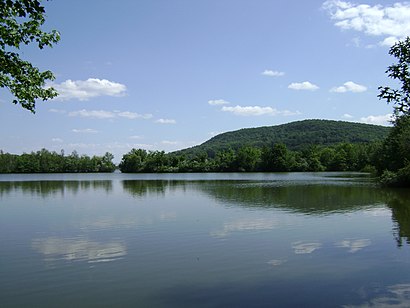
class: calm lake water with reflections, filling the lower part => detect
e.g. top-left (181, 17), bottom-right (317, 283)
top-left (0, 173), bottom-right (410, 307)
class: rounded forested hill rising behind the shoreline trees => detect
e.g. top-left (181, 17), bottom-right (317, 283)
top-left (176, 120), bottom-right (390, 157)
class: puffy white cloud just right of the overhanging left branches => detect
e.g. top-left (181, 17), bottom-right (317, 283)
top-left (49, 78), bottom-right (127, 101)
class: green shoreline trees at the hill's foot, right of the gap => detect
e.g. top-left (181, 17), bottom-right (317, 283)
top-left (119, 143), bottom-right (381, 172)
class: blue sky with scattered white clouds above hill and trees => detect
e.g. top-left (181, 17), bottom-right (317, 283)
top-left (0, 0), bottom-right (410, 162)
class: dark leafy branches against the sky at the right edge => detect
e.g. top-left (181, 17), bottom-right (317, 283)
top-left (378, 37), bottom-right (410, 116)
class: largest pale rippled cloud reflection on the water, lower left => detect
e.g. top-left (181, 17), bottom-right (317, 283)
top-left (32, 237), bottom-right (127, 263)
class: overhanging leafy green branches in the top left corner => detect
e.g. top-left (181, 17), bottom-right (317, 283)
top-left (0, 0), bottom-right (60, 113)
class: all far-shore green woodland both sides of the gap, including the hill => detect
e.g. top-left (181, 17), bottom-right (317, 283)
top-left (0, 120), bottom-right (390, 173)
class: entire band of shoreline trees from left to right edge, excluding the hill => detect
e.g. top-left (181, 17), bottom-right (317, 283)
top-left (0, 116), bottom-right (410, 186)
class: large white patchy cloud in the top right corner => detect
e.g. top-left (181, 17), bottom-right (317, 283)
top-left (323, 0), bottom-right (410, 46)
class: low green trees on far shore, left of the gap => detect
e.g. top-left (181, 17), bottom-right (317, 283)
top-left (0, 149), bottom-right (116, 173)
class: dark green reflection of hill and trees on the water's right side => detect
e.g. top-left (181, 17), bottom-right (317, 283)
top-left (122, 180), bottom-right (410, 247)
